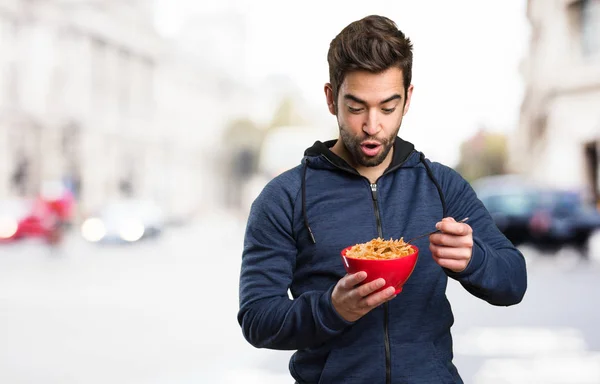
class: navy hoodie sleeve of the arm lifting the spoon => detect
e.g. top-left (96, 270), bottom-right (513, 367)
top-left (440, 166), bottom-right (527, 306)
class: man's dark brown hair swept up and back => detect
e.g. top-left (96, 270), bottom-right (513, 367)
top-left (327, 15), bottom-right (413, 100)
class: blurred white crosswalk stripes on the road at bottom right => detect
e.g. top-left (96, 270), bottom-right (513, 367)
top-left (455, 327), bottom-right (600, 384)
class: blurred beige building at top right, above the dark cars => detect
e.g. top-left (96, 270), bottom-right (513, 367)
top-left (511, 0), bottom-right (600, 202)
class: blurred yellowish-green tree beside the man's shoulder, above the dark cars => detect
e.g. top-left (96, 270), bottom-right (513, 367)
top-left (456, 129), bottom-right (507, 182)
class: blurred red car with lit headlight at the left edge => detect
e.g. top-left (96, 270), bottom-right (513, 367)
top-left (0, 199), bottom-right (59, 243)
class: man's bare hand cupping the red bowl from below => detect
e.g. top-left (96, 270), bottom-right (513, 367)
top-left (331, 272), bottom-right (396, 322)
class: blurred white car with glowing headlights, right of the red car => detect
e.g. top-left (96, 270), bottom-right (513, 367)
top-left (81, 199), bottom-right (165, 243)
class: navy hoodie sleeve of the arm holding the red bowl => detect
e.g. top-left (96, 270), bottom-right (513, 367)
top-left (238, 179), bottom-right (350, 350)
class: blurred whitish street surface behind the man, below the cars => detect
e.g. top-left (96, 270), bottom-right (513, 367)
top-left (0, 213), bottom-right (600, 384)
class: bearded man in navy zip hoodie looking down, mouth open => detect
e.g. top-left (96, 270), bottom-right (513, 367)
top-left (238, 16), bottom-right (527, 384)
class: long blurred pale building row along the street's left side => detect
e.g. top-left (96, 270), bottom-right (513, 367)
top-left (0, 0), bottom-right (324, 219)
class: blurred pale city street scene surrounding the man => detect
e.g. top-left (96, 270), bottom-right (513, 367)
top-left (0, 0), bottom-right (600, 384)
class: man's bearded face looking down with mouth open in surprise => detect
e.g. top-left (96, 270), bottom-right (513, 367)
top-left (325, 68), bottom-right (412, 167)
